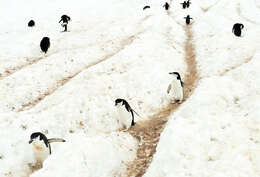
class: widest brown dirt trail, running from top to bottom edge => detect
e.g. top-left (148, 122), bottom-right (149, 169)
top-left (125, 26), bottom-right (198, 177)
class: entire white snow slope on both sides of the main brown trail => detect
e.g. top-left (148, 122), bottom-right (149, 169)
top-left (0, 0), bottom-right (260, 177)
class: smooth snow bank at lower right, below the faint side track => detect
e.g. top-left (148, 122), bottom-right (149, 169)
top-left (145, 53), bottom-right (260, 177)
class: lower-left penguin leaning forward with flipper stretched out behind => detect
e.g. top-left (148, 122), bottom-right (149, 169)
top-left (29, 132), bottom-right (65, 166)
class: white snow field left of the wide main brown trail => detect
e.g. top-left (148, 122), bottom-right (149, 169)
top-left (0, 0), bottom-right (186, 177)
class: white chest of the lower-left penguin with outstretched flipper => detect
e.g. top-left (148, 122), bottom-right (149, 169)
top-left (32, 140), bottom-right (50, 163)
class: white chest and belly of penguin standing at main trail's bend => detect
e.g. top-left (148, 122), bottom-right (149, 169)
top-left (167, 79), bottom-right (183, 103)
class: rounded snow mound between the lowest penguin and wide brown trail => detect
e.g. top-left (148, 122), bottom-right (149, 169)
top-left (30, 133), bottom-right (136, 177)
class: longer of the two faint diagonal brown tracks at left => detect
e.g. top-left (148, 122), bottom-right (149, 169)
top-left (18, 31), bottom-right (144, 112)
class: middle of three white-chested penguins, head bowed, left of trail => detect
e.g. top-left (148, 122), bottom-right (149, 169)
top-left (115, 98), bottom-right (139, 129)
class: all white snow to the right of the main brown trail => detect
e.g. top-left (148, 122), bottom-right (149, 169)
top-left (144, 0), bottom-right (260, 177)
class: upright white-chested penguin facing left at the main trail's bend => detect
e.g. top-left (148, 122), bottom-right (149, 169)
top-left (167, 72), bottom-right (183, 103)
